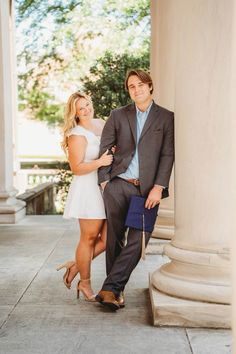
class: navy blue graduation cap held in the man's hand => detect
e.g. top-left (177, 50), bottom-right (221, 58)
top-left (125, 195), bottom-right (159, 232)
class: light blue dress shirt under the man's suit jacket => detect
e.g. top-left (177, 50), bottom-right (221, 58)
top-left (118, 101), bottom-right (153, 179)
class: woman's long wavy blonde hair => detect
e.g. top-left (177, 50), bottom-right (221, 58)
top-left (61, 91), bottom-right (92, 153)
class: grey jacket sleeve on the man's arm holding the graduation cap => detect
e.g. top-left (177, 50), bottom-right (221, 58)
top-left (155, 112), bottom-right (174, 188)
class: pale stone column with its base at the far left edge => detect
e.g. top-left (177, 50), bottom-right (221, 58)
top-left (0, 1), bottom-right (25, 223)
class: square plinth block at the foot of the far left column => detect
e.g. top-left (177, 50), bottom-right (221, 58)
top-left (0, 201), bottom-right (26, 224)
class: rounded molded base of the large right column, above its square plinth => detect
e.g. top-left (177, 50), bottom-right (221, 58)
top-left (152, 243), bottom-right (232, 305)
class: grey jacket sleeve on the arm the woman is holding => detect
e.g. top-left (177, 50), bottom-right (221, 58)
top-left (98, 112), bottom-right (116, 184)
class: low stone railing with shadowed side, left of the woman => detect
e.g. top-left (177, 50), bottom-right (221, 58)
top-left (17, 182), bottom-right (56, 215)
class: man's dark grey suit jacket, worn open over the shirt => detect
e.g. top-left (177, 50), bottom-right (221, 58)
top-left (98, 102), bottom-right (174, 198)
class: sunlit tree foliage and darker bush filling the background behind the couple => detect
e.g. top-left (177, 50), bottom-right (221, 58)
top-left (15, 0), bottom-right (150, 124)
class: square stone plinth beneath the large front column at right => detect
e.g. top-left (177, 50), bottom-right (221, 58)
top-left (149, 277), bottom-right (232, 328)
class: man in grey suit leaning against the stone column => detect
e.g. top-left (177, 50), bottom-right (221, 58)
top-left (96, 70), bottom-right (174, 310)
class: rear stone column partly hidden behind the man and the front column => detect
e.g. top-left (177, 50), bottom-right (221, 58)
top-left (151, 0), bottom-right (175, 240)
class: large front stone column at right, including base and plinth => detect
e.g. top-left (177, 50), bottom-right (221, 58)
top-left (150, 0), bottom-right (233, 328)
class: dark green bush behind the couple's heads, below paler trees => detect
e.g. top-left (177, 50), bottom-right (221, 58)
top-left (82, 52), bottom-right (149, 119)
